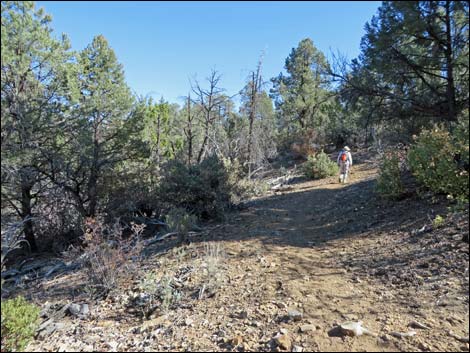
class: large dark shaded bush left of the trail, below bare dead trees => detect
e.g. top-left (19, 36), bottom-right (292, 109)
top-left (158, 156), bottom-right (231, 219)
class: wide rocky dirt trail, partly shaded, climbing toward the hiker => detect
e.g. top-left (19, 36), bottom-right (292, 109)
top-left (15, 153), bottom-right (469, 352)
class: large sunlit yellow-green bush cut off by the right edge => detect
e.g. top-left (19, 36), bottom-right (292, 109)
top-left (408, 124), bottom-right (469, 200)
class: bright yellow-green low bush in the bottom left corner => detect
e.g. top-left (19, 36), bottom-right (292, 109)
top-left (1, 297), bottom-right (40, 352)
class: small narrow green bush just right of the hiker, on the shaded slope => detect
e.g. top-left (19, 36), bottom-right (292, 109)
top-left (375, 152), bottom-right (404, 199)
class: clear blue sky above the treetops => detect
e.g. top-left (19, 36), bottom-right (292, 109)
top-left (36, 1), bottom-right (381, 103)
